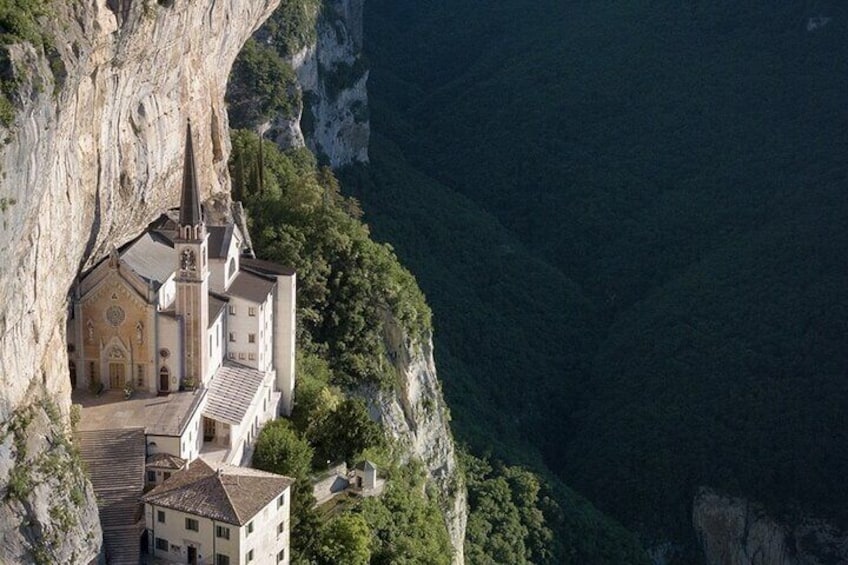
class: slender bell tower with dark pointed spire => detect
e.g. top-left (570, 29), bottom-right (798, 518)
top-left (174, 121), bottom-right (209, 386)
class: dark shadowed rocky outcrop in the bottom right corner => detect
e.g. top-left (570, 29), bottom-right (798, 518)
top-left (692, 488), bottom-right (848, 565)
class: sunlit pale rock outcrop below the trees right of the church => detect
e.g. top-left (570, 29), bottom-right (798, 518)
top-left (367, 319), bottom-right (468, 564)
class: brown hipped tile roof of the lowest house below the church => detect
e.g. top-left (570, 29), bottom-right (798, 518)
top-left (141, 459), bottom-right (294, 526)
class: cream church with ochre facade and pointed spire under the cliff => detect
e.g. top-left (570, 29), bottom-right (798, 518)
top-left (67, 124), bottom-right (296, 468)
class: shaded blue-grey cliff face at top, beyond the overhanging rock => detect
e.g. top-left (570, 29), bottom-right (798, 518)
top-left (291, 0), bottom-right (371, 168)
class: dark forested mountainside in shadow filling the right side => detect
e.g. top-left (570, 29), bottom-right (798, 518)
top-left (350, 0), bottom-right (848, 562)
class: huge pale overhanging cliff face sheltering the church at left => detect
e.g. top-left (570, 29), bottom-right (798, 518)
top-left (0, 0), bottom-right (278, 563)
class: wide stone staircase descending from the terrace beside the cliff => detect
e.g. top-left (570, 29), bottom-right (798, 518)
top-left (76, 428), bottom-right (145, 565)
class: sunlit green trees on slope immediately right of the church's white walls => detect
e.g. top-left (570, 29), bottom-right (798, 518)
top-left (230, 131), bottom-right (430, 387)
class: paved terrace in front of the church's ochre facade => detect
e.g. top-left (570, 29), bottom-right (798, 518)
top-left (72, 389), bottom-right (206, 436)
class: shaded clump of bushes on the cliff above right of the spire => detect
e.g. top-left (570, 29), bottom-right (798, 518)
top-left (227, 39), bottom-right (300, 128)
